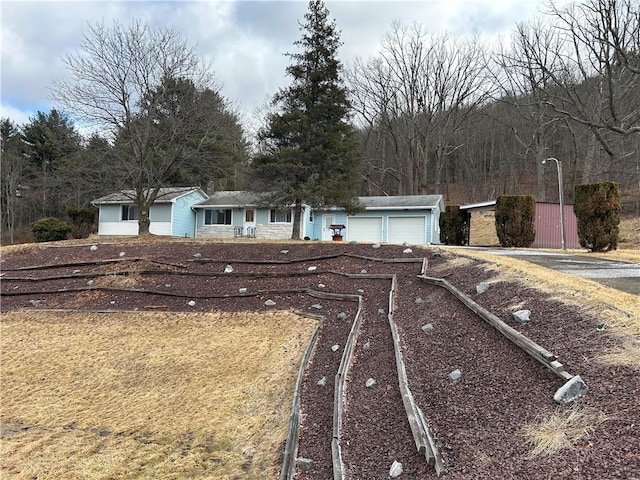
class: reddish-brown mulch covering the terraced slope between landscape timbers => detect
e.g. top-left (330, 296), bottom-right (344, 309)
top-left (0, 242), bottom-right (640, 480)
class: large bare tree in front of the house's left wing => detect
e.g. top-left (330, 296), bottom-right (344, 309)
top-left (53, 21), bottom-right (244, 234)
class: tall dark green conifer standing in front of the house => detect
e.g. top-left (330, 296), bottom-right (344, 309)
top-left (252, 0), bottom-right (360, 240)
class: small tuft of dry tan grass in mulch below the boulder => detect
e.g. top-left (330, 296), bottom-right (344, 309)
top-left (523, 408), bottom-right (607, 457)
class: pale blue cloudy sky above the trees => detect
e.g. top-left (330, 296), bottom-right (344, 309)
top-left (0, 0), bottom-right (560, 135)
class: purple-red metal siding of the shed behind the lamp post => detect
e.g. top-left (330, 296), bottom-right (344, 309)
top-left (531, 202), bottom-right (581, 248)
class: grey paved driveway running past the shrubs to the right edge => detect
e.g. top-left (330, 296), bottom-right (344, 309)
top-left (460, 247), bottom-right (640, 296)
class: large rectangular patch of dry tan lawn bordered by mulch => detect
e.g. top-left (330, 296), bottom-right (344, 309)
top-left (0, 312), bottom-right (315, 479)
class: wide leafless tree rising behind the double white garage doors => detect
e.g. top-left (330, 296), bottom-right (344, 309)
top-left (348, 23), bottom-right (490, 198)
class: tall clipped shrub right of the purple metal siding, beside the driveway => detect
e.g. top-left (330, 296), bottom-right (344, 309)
top-left (573, 182), bottom-right (622, 252)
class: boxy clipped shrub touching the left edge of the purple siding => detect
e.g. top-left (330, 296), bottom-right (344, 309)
top-left (496, 195), bottom-right (536, 247)
